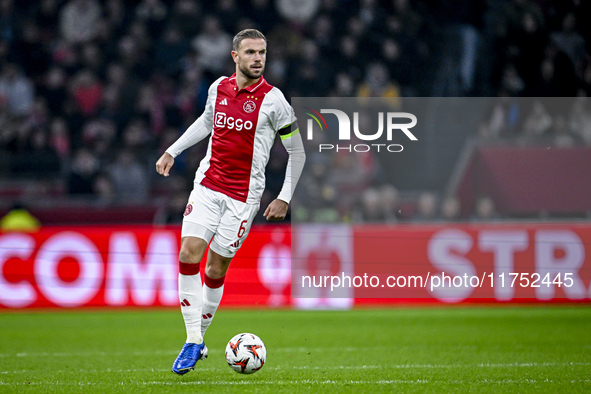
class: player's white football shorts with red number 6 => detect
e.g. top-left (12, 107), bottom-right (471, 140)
top-left (181, 184), bottom-right (260, 258)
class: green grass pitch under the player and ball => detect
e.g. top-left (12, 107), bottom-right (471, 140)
top-left (0, 305), bottom-right (591, 393)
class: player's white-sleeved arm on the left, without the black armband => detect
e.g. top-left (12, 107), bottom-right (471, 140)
top-left (156, 77), bottom-right (224, 176)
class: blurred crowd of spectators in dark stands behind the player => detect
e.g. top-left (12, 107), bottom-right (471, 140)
top-left (0, 0), bottom-right (591, 223)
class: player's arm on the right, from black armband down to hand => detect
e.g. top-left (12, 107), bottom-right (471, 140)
top-left (263, 120), bottom-right (306, 221)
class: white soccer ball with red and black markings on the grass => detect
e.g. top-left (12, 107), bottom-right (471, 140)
top-left (226, 333), bottom-right (267, 374)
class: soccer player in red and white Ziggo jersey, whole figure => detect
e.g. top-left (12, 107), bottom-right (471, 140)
top-left (156, 29), bottom-right (306, 375)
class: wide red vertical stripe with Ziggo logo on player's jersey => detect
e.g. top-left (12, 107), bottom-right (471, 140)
top-left (201, 78), bottom-right (272, 202)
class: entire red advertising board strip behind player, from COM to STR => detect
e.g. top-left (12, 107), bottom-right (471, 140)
top-left (0, 223), bottom-right (591, 308)
